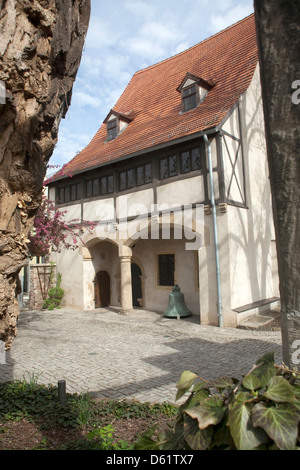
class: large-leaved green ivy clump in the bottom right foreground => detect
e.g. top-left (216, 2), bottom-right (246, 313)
top-left (134, 353), bottom-right (300, 450)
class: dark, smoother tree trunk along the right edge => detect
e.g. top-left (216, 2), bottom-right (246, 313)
top-left (254, 0), bottom-right (300, 368)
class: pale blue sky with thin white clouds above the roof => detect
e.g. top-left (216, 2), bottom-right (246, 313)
top-left (49, 0), bottom-right (254, 174)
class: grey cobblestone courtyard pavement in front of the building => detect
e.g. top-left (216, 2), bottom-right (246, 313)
top-left (0, 308), bottom-right (282, 402)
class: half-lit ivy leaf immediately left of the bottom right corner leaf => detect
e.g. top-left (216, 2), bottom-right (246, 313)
top-left (227, 403), bottom-right (265, 450)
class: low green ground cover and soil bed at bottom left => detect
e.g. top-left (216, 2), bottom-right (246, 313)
top-left (0, 377), bottom-right (177, 450)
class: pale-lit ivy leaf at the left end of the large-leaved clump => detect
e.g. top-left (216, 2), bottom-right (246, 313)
top-left (186, 397), bottom-right (225, 429)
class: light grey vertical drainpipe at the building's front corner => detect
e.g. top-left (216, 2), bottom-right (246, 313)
top-left (203, 134), bottom-right (223, 328)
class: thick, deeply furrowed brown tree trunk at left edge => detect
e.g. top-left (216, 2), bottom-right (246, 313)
top-left (0, 0), bottom-right (90, 348)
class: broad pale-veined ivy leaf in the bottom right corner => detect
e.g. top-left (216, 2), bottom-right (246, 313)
top-left (252, 403), bottom-right (300, 450)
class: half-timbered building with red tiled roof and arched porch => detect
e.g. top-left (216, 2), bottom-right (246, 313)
top-left (49, 15), bottom-right (278, 326)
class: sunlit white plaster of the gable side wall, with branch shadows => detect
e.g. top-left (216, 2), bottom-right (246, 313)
top-left (227, 63), bottom-right (278, 309)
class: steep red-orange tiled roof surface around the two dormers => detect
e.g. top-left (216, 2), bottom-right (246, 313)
top-left (57, 15), bottom-right (258, 178)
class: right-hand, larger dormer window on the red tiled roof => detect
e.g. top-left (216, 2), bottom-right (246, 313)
top-left (177, 73), bottom-right (213, 113)
